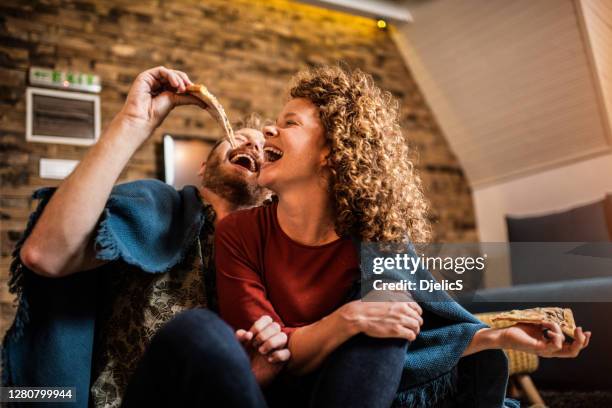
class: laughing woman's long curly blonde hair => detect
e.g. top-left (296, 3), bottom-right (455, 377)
top-left (289, 66), bottom-right (431, 243)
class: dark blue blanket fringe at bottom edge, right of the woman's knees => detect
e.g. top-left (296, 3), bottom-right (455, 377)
top-left (393, 368), bottom-right (457, 408)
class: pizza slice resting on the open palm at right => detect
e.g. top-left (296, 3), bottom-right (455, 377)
top-left (491, 307), bottom-right (576, 339)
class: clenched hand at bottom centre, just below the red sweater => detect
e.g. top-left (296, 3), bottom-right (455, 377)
top-left (236, 316), bottom-right (291, 386)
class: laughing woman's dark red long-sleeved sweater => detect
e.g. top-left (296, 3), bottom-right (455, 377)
top-left (215, 203), bottom-right (359, 335)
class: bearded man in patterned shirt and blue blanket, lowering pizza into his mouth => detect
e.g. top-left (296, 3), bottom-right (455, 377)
top-left (2, 67), bottom-right (289, 407)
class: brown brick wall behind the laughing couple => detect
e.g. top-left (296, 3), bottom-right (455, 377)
top-left (0, 0), bottom-right (477, 334)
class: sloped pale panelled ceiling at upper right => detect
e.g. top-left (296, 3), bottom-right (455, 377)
top-left (395, 0), bottom-right (612, 186)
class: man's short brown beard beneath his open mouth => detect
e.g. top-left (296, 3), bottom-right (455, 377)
top-left (202, 155), bottom-right (267, 208)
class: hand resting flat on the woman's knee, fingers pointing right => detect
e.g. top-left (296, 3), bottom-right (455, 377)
top-left (339, 300), bottom-right (423, 341)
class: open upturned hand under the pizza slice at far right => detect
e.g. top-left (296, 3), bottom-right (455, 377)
top-left (499, 323), bottom-right (591, 358)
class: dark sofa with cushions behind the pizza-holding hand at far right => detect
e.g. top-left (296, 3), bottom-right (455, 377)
top-left (462, 194), bottom-right (612, 390)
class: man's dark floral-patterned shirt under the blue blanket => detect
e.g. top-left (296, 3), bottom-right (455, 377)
top-left (91, 203), bottom-right (216, 407)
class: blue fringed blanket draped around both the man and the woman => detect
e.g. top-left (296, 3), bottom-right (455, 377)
top-left (2, 180), bottom-right (518, 408)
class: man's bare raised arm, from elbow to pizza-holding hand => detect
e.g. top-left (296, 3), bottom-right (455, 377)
top-left (20, 67), bottom-right (203, 277)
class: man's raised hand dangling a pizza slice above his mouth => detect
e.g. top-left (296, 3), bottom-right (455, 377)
top-left (119, 66), bottom-right (206, 134)
